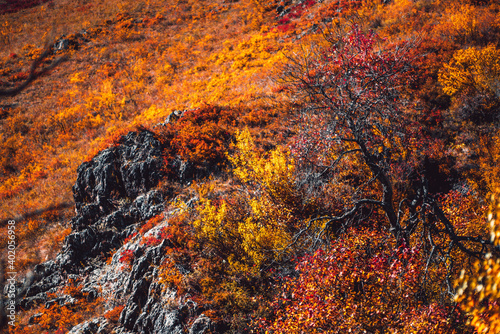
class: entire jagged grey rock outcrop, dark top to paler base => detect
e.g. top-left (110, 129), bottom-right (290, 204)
top-left (20, 131), bottom-right (213, 334)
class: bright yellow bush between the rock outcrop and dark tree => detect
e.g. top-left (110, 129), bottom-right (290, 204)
top-left (194, 130), bottom-right (300, 274)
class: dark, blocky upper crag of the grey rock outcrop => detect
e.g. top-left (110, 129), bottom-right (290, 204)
top-left (73, 131), bottom-right (163, 222)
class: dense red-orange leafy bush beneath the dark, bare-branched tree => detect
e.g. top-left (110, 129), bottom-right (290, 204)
top-left (261, 229), bottom-right (463, 333)
